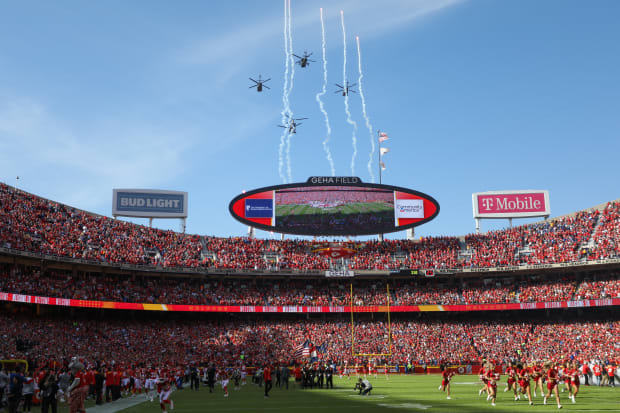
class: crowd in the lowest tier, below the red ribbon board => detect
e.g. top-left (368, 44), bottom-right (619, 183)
top-left (0, 314), bottom-right (620, 365)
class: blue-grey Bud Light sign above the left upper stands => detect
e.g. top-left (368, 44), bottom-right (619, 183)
top-left (112, 190), bottom-right (187, 218)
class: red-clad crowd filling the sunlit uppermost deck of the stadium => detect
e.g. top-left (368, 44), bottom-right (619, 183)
top-left (0, 183), bottom-right (620, 272)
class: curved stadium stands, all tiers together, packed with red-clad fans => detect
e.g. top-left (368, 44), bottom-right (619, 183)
top-left (0, 184), bottom-right (620, 412)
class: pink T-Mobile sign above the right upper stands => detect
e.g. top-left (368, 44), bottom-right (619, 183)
top-left (472, 190), bottom-right (551, 218)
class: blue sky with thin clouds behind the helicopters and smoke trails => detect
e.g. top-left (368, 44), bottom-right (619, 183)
top-left (0, 0), bottom-right (620, 237)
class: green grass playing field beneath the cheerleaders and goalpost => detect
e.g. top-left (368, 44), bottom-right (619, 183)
top-left (94, 376), bottom-right (620, 413)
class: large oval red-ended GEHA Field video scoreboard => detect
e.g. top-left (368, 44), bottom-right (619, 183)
top-left (229, 177), bottom-right (439, 236)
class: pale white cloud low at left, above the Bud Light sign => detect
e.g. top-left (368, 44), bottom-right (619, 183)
top-left (0, 98), bottom-right (192, 209)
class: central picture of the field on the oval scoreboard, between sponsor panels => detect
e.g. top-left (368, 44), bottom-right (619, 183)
top-left (275, 186), bottom-right (394, 235)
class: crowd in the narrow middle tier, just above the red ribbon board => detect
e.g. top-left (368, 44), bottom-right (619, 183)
top-left (0, 265), bottom-right (620, 306)
